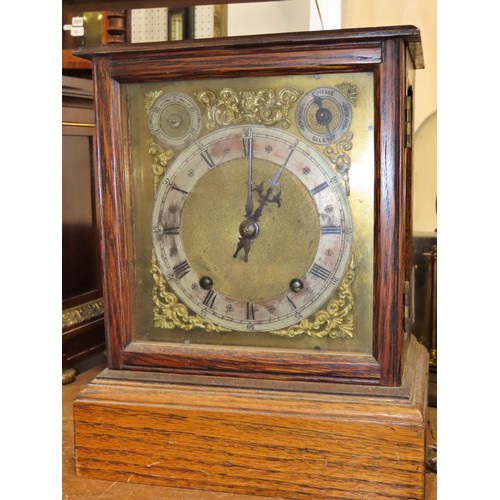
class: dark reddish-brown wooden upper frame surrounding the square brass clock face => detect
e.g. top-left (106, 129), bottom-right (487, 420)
top-left (78, 27), bottom-right (422, 386)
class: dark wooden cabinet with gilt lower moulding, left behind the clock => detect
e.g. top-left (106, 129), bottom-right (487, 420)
top-left (62, 76), bottom-right (105, 381)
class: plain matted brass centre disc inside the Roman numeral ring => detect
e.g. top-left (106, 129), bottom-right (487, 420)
top-left (180, 159), bottom-right (320, 301)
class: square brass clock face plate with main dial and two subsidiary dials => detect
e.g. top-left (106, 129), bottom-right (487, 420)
top-left (124, 72), bottom-right (374, 352)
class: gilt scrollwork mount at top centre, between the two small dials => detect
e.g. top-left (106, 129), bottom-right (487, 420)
top-left (194, 88), bottom-right (301, 130)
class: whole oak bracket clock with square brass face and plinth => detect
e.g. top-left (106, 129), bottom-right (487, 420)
top-left (74, 26), bottom-right (427, 498)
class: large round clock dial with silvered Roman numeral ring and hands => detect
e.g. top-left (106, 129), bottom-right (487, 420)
top-left (152, 126), bottom-right (352, 331)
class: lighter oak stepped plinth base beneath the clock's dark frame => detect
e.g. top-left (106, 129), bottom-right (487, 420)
top-left (74, 340), bottom-right (428, 499)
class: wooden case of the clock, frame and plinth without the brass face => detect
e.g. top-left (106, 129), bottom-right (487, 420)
top-left (74, 26), bottom-right (428, 498)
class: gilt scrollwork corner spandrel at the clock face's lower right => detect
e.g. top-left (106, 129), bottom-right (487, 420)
top-left (270, 255), bottom-right (356, 339)
